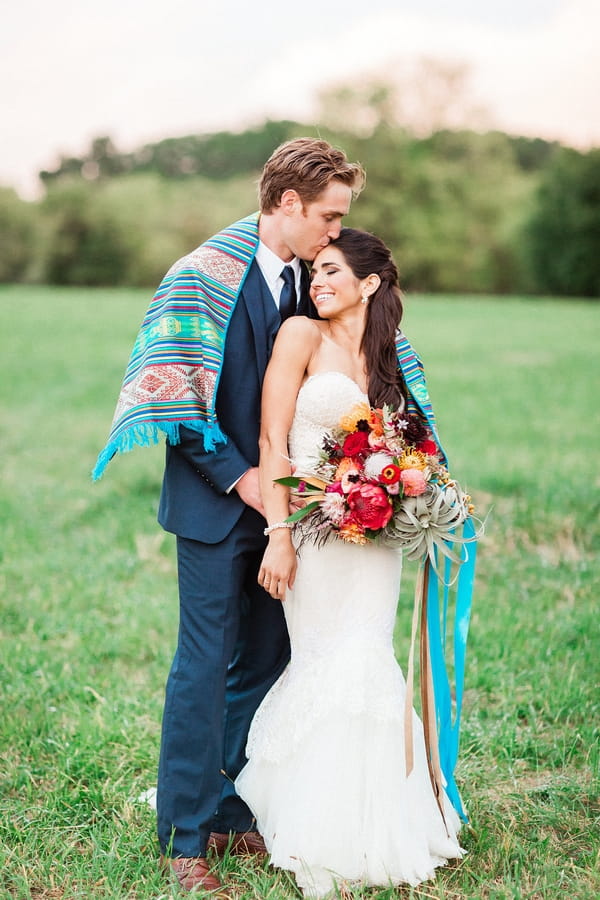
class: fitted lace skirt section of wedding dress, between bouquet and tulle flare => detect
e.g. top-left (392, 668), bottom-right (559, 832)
top-left (247, 541), bottom-right (408, 763)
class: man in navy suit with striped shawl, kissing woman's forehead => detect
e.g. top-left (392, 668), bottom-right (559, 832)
top-left (94, 138), bottom-right (364, 896)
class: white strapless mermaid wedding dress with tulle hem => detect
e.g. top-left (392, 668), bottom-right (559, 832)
top-left (236, 372), bottom-right (462, 897)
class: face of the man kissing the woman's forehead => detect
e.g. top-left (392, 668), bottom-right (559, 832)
top-left (286, 179), bottom-right (352, 262)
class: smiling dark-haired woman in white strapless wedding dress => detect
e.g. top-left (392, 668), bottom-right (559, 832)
top-left (236, 228), bottom-right (463, 897)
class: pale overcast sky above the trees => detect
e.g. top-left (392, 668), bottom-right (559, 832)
top-left (0, 0), bottom-right (600, 196)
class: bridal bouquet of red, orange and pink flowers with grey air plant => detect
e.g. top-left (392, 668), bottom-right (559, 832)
top-left (277, 403), bottom-right (473, 562)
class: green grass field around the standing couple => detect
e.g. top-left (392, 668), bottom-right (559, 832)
top-left (0, 287), bottom-right (600, 900)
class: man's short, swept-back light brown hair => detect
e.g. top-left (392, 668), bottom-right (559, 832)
top-left (258, 138), bottom-right (365, 213)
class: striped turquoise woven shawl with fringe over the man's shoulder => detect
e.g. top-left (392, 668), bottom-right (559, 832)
top-left (92, 213), bottom-right (258, 479)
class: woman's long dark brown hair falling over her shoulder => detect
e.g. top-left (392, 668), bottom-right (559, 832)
top-left (330, 228), bottom-right (407, 407)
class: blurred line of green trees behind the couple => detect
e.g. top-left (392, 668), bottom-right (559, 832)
top-left (0, 119), bottom-right (600, 298)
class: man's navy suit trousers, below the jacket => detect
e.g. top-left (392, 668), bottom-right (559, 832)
top-left (157, 507), bottom-right (290, 856)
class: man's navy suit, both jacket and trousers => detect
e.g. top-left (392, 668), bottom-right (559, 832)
top-left (157, 261), bottom-right (315, 856)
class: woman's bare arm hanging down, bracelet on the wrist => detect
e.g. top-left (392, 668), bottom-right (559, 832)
top-left (258, 316), bottom-right (320, 600)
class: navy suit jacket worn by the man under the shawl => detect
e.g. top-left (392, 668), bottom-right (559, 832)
top-left (158, 260), bottom-right (316, 544)
